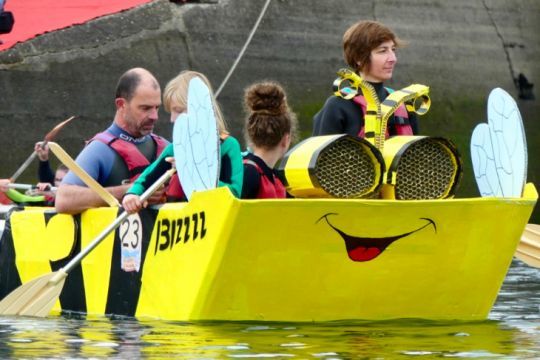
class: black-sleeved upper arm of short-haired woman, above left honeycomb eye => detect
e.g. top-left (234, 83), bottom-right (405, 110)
top-left (313, 96), bottom-right (364, 136)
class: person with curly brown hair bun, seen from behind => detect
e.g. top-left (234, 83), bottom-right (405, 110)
top-left (242, 82), bottom-right (297, 199)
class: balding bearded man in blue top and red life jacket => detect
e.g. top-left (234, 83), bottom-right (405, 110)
top-left (55, 68), bottom-right (168, 214)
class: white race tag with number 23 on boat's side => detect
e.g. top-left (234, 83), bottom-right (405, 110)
top-left (118, 213), bottom-right (142, 272)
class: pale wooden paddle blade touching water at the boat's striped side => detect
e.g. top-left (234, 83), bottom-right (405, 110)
top-left (0, 271), bottom-right (67, 317)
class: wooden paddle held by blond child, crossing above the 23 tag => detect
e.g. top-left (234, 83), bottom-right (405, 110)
top-left (0, 167), bottom-right (176, 317)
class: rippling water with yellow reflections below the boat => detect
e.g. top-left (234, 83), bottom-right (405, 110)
top-left (0, 261), bottom-right (540, 360)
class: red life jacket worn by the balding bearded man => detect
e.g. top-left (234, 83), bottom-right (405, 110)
top-left (90, 131), bottom-right (167, 182)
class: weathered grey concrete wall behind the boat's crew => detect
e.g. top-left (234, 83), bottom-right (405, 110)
top-left (0, 0), bottom-right (540, 221)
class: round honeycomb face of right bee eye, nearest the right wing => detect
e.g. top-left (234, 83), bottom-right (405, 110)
top-left (395, 139), bottom-right (457, 200)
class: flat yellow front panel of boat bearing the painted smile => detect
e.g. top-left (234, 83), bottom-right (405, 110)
top-left (185, 190), bottom-right (534, 321)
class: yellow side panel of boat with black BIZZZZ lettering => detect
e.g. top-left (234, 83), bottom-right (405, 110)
top-left (136, 188), bottom-right (235, 319)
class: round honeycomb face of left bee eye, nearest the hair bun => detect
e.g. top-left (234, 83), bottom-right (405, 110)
top-left (314, 138), bottom-right (381, 198)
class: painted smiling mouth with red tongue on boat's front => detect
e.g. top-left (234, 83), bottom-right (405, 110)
top-left (317, 213), bottom-right (437, 261)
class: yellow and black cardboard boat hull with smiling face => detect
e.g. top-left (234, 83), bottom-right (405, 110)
top-left (0, 184), bottom-right (538, 321)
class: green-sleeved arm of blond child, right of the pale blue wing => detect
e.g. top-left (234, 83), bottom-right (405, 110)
top-left (218, 136), bottom-right (244, 198)
